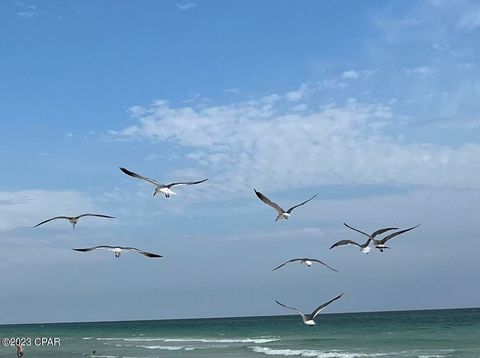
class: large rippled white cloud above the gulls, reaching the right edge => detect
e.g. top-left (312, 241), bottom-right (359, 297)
top-left (112, 88), bottom-right (480, 197)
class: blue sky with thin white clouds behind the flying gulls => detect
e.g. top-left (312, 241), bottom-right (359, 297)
top-left (0, 0), bottom-right (480, 323)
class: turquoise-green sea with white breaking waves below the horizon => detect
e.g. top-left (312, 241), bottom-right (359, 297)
top-left (0, 308), bottom-right (480, 358)
